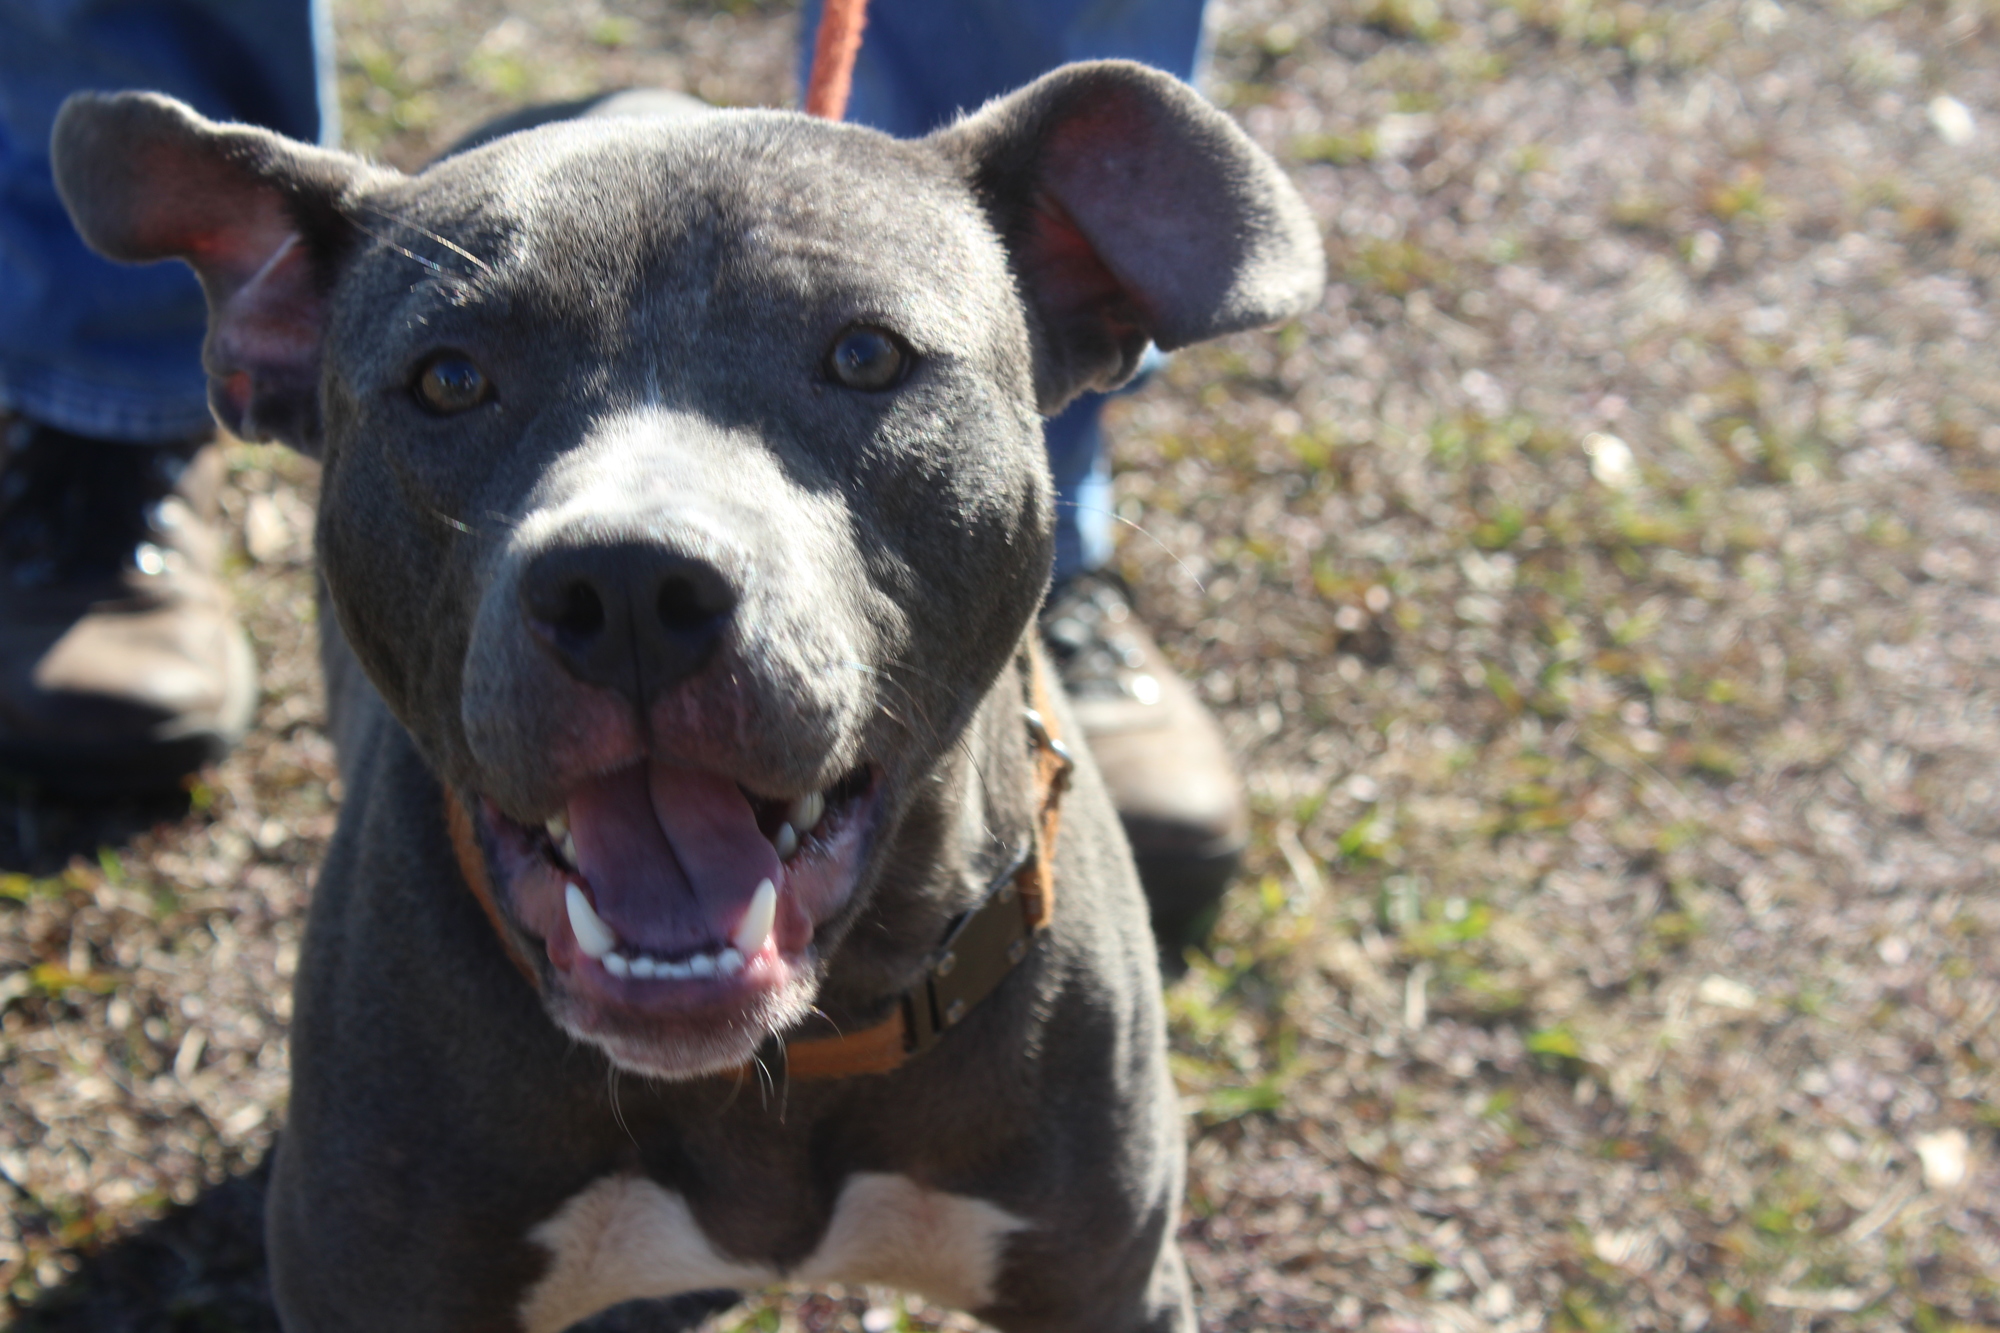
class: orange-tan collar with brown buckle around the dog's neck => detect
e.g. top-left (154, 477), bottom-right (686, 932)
top-left (444, 646), bottom-right (1076, 1079)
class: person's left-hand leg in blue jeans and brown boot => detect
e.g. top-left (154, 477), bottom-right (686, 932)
top-left (0, 0), bottom-right (330, 791)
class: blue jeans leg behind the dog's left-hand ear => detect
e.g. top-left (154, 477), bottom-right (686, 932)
top-left (0, 0), bottom-right (336, 444)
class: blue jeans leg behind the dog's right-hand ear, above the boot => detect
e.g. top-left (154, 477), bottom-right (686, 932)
top-left (798, 0), bottom-right (1204, 582)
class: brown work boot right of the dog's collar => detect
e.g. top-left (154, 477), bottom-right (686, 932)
top-left (1042, 570), bottom-right (1250, 975)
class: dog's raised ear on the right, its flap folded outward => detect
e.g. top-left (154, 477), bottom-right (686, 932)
top-left (930, 60), bottom-right (1326, 412)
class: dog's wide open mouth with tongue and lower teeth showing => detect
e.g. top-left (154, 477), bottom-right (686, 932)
top-left (486, 763), bottom-right (878, 1073)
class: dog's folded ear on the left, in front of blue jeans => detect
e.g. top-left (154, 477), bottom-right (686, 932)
top-left (50, 92), bottom-right (388, 452)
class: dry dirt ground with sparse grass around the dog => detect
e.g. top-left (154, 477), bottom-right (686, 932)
top-left (0, 0), bottom-right (2000, 1333)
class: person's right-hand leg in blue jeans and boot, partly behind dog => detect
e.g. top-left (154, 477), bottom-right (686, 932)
top-left (800, 0), bottom-right (1248, 967)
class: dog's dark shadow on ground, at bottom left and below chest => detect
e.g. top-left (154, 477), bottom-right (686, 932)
top-left (4, 1157), bottom-right (736, 1333)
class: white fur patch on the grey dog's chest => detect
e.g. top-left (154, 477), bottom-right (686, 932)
top-left (520, 1173), bottom-right (1028, 1333)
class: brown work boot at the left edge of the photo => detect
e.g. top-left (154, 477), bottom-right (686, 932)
top-left (0, 416), bottom-right (256, 797)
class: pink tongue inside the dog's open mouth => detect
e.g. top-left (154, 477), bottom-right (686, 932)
top-left (568, 765), bottom-right (778, 959)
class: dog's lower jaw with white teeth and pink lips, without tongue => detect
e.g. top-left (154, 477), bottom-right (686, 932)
top-left (480, 767), bottom-right (880, 1079)
